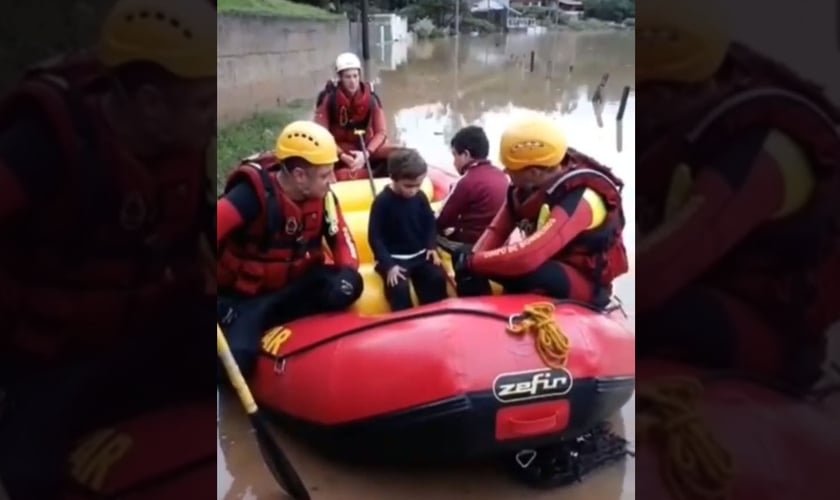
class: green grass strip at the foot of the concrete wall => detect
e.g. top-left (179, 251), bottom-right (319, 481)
top-left (216, 101), bottom-right (311, 191)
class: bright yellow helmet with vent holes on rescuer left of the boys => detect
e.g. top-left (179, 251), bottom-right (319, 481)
top-left (274, 120), bottom-right (338, 165)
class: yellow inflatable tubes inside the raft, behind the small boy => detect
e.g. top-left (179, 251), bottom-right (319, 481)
top-left (332, 178), bottom-right (502, 316)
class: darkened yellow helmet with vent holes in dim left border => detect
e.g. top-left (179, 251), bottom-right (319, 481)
top-left (99, 0), bottom-right (216, 78)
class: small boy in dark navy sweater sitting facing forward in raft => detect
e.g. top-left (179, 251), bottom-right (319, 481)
top-left (368, 149), bottom-right (446, 312)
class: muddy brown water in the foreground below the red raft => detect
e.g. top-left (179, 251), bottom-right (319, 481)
top-left (217, 388), bottom-right (636, 500)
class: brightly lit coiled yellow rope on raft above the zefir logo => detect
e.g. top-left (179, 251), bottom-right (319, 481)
top-left (507, 302), bottom-right (571, 368)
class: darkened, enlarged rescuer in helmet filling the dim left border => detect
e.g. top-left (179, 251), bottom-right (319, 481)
top-left (0, 0), bottom-right (216, 499)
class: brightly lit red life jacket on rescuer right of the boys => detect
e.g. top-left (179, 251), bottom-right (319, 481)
top-left (507, 148), bottom-right (629, 291)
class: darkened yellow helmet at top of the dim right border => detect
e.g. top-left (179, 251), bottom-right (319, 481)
top-left (636, 0), bottom-right (731, 83)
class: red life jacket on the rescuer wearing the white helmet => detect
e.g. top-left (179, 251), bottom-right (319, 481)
top-left (316, 80), bottom-right (382, 147)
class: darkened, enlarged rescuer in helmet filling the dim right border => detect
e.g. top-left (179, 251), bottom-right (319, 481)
top-left (636, 0), bottom-right (840, 390)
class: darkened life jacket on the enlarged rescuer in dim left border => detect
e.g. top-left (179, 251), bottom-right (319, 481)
top-left (0, 53), bottom-right (209, 358)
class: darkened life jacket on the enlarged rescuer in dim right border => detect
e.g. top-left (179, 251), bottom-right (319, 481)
top-left (637, 44), bottom-right (840, 337)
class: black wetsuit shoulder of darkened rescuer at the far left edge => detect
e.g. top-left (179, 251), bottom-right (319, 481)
top-left (0, 112), bottom-right (65, 201)
